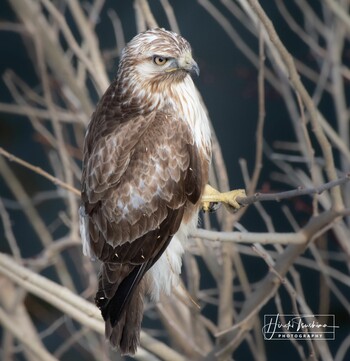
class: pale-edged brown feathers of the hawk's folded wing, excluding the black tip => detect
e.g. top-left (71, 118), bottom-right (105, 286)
top-left (82, 113), bottom-right (201, 264)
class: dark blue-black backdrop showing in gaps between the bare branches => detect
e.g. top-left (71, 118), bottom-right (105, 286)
top-left (0, 0), bottom-right (350, 360)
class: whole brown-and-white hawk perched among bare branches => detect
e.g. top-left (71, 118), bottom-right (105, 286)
top-left (80, 28), bottom-right (242, 354)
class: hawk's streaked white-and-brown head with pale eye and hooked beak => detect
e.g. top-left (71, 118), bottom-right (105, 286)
top-left (118, 28), bottom-right (199, 85)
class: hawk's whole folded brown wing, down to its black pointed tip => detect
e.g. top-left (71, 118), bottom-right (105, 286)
top-left (82, 85), bottom-right (202, 327)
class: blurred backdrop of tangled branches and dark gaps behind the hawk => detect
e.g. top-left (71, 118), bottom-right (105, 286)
top-left (0, 0), bottom-right (350, 360)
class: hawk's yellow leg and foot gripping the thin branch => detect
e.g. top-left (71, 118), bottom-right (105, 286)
top-left (202, 184), bottom-right (246, 212)
